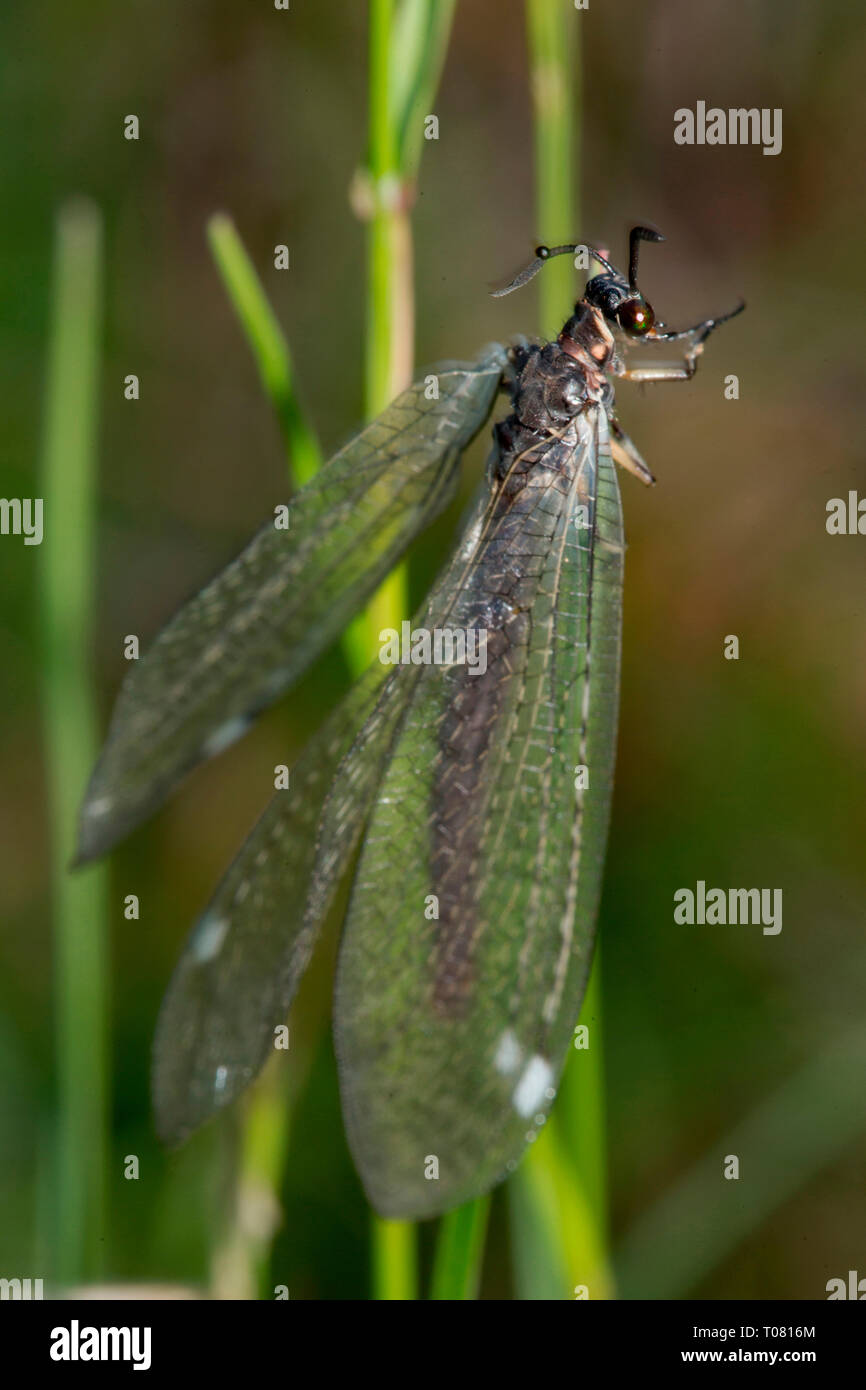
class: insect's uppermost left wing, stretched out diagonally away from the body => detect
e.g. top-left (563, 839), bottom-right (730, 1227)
top-left (78, 345), bottom-right (505, 862)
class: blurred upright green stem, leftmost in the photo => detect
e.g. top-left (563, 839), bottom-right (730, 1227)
top-left (39, 200), bottom-right (108, 1284)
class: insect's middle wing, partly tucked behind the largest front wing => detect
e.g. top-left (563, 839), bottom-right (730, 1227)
top-left (153, 663), bottom-right (413, 1144)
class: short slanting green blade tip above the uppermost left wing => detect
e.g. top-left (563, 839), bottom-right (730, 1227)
top-left (207, 213), bottom-right (321, 487)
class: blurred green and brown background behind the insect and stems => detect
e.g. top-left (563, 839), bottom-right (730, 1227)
top-left (0, 0), bottom-right (866, 1298)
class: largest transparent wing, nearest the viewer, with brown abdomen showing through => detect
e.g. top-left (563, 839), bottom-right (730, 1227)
top-left (335, 409), bottom-right (623, 1216)
